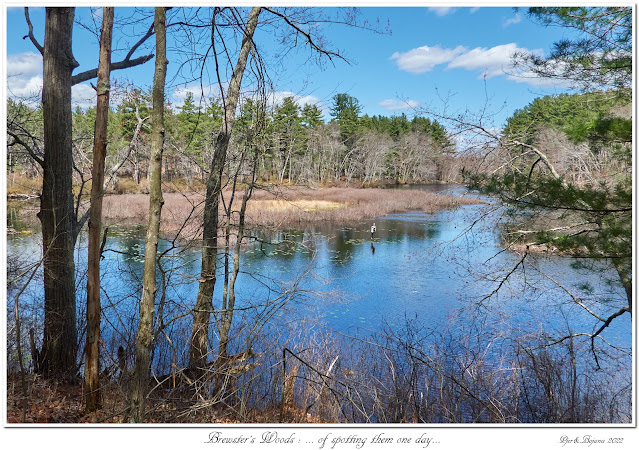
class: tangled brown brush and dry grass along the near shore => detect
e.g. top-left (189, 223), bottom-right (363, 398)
top-left (8, 292), bottom-right (633, 424)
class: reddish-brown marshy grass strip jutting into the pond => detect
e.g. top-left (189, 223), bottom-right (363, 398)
top-left (97, 187), bottom-right (481, 238)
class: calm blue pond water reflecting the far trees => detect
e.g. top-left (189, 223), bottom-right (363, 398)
top-left (7, 186), bottom-right (632, 354)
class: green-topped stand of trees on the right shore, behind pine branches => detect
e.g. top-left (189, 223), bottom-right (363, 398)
top-left (497, 90), bottom-right (632, 186)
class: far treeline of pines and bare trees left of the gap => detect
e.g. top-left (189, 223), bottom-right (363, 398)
top-left (7, 89), bottom-right (460, 191)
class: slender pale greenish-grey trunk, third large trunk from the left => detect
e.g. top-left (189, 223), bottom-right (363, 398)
top-left (130, 8), bottom-right (168, 422)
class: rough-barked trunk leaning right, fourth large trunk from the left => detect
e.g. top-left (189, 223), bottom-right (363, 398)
top-left (189, 7), bottom-right (261, 370)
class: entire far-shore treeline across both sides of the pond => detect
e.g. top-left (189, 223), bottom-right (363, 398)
top-left (7, 89), bottom-right (632, 196)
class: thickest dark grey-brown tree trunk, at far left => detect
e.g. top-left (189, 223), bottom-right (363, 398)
top-left (38, 8), bottom-right (78, 380)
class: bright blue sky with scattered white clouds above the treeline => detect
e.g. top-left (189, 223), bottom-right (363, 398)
top-left (6, 4), bottom-right (580, 127)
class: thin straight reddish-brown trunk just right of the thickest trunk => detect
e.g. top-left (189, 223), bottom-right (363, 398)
top-left (84, 7), bottom-right (113, 412)
